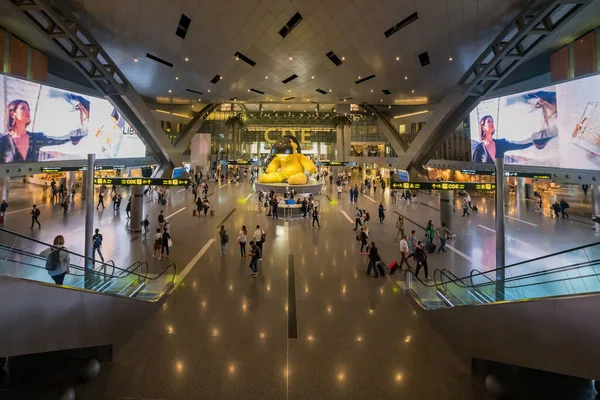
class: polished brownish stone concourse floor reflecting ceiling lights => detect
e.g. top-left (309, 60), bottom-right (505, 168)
top-left (4, 183), bottom-right (598, 400)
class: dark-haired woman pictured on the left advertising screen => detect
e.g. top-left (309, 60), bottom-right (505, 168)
top-left (0, 99), bottom-right (69, 164)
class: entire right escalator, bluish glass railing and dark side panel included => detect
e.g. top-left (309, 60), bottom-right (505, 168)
top-left (404, 243), bottom-right (600, 379)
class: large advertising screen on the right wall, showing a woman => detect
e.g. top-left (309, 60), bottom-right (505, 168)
top-left (469, 76), bottom-right (600, 170)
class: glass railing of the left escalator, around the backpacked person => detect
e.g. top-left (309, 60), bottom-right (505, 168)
top-left (0, 228), bottom-right (177, 301)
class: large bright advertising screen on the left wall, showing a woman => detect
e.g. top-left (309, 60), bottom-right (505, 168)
top-left (0, 75), bottom-right (146, 164)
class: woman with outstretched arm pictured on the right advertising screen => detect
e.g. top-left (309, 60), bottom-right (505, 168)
top-left (473, 115), bottom-right (533, 164)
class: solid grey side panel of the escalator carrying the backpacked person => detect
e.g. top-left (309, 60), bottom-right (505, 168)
top-left (0, 276), bottom-right (164, 356)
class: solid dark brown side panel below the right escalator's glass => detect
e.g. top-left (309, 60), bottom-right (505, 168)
top-left (420, 294), bottom-right (600, 379)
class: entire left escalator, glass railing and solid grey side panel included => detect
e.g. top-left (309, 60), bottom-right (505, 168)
top-left (0, 228), bottom-right (177, 357)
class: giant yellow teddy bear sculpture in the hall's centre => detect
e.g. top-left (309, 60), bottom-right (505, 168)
top-left (259, 135), bottom-right (317, 185)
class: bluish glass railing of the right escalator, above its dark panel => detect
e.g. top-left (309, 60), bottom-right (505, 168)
top-left (404, 243), bottom-right (600, 309)
